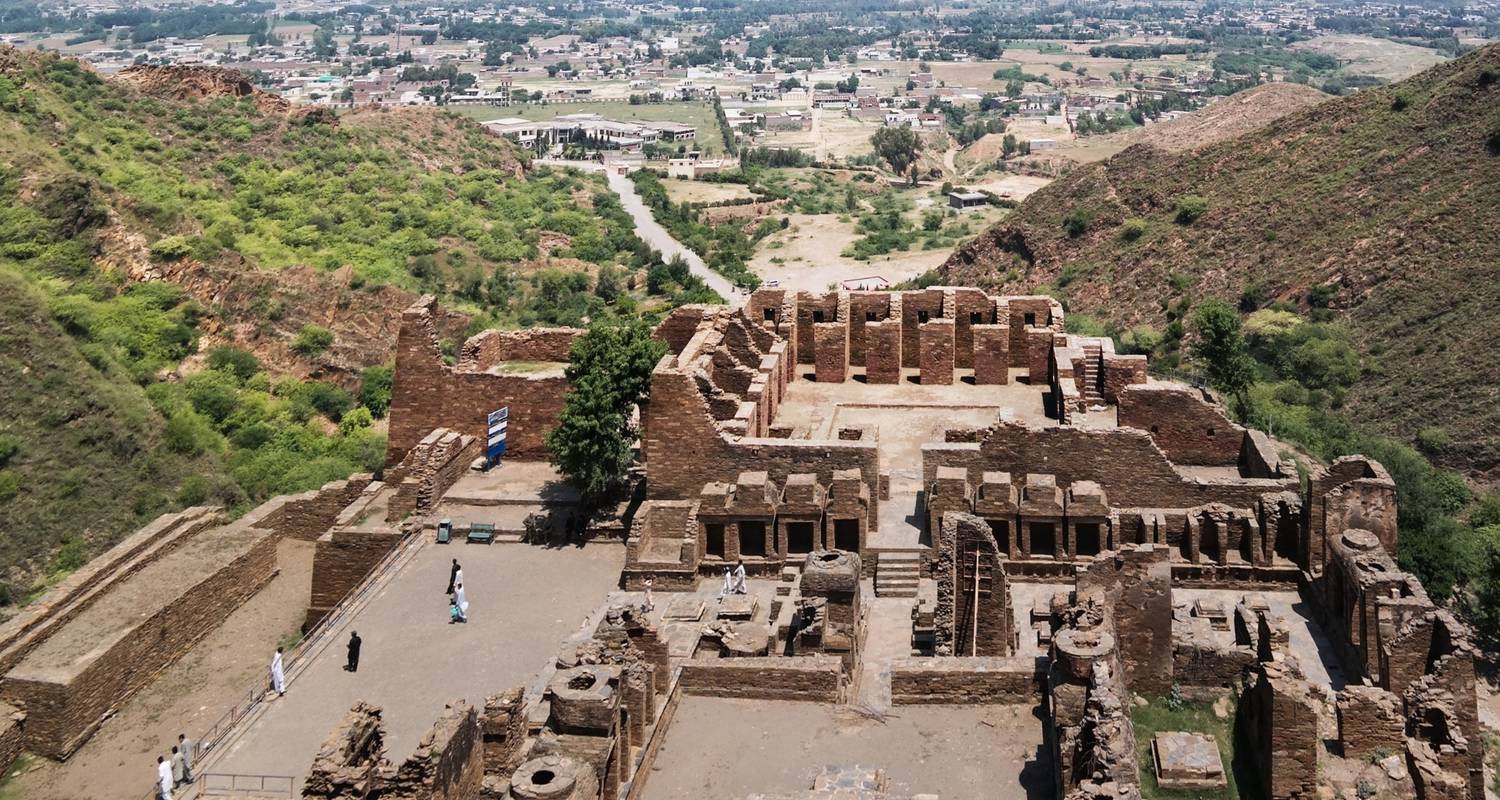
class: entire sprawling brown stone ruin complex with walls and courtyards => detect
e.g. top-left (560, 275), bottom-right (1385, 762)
top-left (0, 287), bottom-right (1485, 800)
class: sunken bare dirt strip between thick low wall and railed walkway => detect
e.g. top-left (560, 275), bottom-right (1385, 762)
top-left (15, 540), bottom-right (314, 800)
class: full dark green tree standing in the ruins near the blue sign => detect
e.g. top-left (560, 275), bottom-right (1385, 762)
top-left (548, 320), bottom-right (666, 507)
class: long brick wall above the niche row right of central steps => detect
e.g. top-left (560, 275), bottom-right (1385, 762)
top-left (923, 422), bottom-right (1296, 509)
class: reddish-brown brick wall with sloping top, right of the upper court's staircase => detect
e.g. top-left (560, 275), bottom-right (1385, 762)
top-left (1118, 383), bottom-right (1245, 467)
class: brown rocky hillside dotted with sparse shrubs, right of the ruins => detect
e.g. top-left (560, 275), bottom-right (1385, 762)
top-left (941, 45), bottom-right (1500, 480)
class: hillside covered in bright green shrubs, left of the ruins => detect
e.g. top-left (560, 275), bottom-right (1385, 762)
top-left (0, 48), bottom-right (680, 585)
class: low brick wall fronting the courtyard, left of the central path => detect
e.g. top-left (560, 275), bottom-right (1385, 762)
top-left (678, 656), bottom-right (843, 702)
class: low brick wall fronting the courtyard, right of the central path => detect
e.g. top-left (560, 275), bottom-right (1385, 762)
top-left (891, 656), bottom-right (1047, 705)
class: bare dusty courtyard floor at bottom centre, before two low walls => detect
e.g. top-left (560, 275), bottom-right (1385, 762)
top-left (644, 696), bottom-right (1052, 800)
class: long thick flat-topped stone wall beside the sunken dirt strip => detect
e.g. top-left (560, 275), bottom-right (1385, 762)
top-left (0, 521), bottom-right (278, 758)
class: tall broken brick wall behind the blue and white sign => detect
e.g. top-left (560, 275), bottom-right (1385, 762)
top-left (386, 296), bottom-right (569, 465)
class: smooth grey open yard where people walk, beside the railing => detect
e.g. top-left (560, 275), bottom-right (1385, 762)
top-left (210, 542), bottom-right (624, 782)
